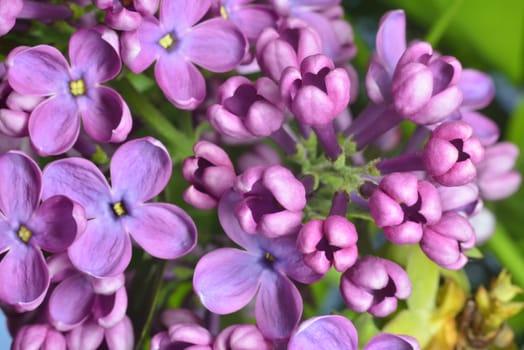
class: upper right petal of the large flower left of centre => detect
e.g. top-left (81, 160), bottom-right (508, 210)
top-left (111, 137), bottom-right (172, 203)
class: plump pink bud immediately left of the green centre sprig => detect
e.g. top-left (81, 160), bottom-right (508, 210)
top-left (234, 165), bottom-right (306, 237)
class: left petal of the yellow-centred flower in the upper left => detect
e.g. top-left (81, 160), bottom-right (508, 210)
top-left (8, 45), bottom-right (70, 96)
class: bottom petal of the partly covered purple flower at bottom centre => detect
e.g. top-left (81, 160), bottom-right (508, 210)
top-left (255, 271), bottom-right (302, 339)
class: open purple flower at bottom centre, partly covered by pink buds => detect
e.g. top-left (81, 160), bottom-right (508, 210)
top-left (193, 191), bottom-right (321, 339)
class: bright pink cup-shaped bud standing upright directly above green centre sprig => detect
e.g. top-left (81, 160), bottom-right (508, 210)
top-left (280, 54), bottom-right (350, 126)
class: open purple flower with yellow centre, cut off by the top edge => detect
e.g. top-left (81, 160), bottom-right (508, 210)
top-left (122, 0), bottom-right (247, 109)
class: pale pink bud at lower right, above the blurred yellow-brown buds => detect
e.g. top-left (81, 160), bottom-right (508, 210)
top-left (420, 212), bottom-right (475, 270)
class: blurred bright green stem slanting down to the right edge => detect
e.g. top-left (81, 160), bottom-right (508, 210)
top-left (487, 225), bottom-right (524, 288)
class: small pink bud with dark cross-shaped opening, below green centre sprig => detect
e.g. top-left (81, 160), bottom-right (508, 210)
top-left (297, 215), bottom-right (358, 274)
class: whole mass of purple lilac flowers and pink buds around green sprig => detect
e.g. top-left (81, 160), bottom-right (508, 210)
top-left (0, 0), bottom-right (521, 350)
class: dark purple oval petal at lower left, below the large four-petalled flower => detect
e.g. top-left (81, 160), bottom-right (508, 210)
top-left (48, 274), bottom-right (95, 331)
